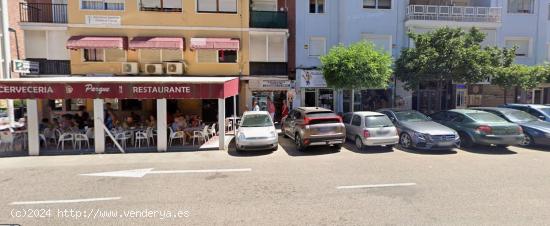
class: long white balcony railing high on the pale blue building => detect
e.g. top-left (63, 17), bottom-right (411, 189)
top-left (407, 5), bottom-right (502, 23)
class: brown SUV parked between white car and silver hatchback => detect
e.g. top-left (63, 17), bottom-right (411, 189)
top-left (281, 107), bottom-right (346, 151)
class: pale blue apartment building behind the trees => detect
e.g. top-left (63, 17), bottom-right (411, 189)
top-left (294, 0), bottom-right (550, 112)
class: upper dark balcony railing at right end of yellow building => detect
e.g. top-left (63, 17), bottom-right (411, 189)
top-left (250, 11), bottom-right (288, 28)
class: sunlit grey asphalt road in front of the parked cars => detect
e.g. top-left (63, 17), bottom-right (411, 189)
top-left (0, 138), bottom-right (550, 225)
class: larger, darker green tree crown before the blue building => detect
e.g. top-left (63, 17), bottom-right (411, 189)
top-left (395, 27), bottom-right (500, 89)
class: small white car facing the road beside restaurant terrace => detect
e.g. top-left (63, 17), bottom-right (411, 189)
top-left (235, 111), bottom-right (279, 152)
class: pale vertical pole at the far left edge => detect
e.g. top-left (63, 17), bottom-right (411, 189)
top-left (0, 0), bottom-right (15, 123)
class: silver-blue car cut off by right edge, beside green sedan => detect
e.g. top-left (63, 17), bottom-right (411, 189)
top-left (474, 107), bottom-right (550, 146)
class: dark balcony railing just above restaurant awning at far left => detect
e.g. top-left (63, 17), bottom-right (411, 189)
top-left (26, 59), bottom-right (71, 75)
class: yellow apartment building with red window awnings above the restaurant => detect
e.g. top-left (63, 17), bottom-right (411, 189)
top-left (20, 0), bottom-right (294, 121)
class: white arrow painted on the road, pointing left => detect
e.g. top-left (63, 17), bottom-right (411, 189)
top-left (80, 168), bottom-right (252, 178)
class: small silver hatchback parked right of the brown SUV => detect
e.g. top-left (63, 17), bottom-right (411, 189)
top-left (343, 111), bottom-right (399, 150)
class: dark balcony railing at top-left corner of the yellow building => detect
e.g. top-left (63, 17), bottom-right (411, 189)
top-left (19, 2), bottom-right (67, 24)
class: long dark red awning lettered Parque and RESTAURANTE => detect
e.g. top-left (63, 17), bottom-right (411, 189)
top-left (0, 76), bottom-right (239, 99)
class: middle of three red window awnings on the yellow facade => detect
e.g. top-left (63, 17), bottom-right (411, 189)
top-left (129, 37), bottom-right (185, 49)
